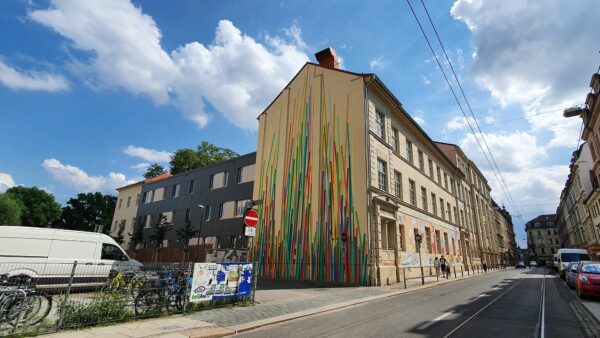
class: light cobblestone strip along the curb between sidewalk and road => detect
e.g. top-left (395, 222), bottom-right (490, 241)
top-left (189, 287), bottom-right (393, 326)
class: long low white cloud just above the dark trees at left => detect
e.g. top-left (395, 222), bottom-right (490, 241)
top-left (42, 158), bottom-right (135, 194)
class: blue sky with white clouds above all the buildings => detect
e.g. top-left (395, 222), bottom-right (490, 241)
top-left (0, 0), bottom-right (600, 248)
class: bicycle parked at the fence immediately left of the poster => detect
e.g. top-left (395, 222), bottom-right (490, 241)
top-left (134, 269), bottom-right (188, 316)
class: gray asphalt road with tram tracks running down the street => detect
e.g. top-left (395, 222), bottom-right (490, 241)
top-left (240, 268), bottom-right (600, 338)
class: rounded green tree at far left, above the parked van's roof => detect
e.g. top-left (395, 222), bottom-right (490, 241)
top-left (6, 186), bottom-right (61, 227)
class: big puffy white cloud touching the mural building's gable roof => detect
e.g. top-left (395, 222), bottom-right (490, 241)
top-left (171, 20), bottom-right (308, 130)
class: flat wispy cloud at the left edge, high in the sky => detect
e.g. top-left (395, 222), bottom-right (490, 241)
top-left (0, 61), bottom-right (69, 92)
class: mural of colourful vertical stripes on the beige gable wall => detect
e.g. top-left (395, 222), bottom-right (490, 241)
top-left (250, 74), bottom-right (368, 285)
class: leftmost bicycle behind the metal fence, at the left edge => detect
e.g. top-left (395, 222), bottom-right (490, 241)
top-left (0, 275), bottom-right (52, 327)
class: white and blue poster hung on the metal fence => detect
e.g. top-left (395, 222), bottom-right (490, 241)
top-left (190, 263), bottom-right (252, 302)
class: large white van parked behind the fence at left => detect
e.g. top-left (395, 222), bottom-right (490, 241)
top-left (0, 226), bottom-right (143, 288)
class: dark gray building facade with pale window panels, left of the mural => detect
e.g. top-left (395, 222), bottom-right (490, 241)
top-left (136, 153), bottom-right (256, 249)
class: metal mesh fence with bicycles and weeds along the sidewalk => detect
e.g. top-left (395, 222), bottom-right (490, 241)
top-left (0, 261), bottom-right (256, 336)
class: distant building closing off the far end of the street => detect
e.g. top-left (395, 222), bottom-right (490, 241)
top-left (525, 214), bottom-right (560, 264)
